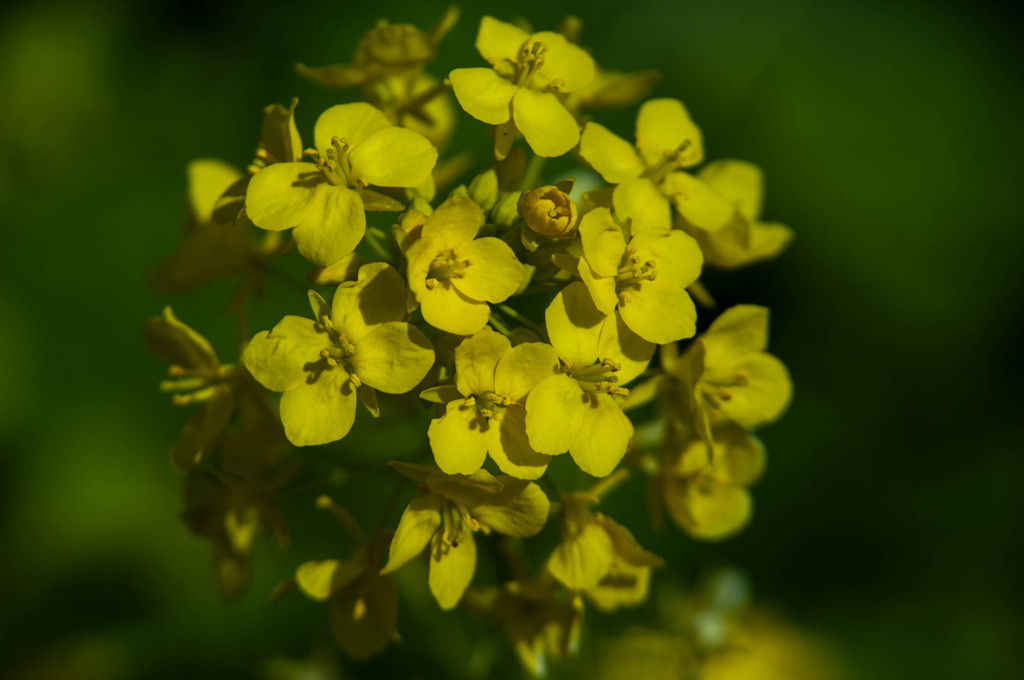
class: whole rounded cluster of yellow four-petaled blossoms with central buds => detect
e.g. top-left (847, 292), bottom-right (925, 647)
top-left (146, 10), bottom-right (791, 672)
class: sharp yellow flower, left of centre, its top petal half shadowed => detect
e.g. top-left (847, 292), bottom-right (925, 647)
top-left (244, 262), bottom-right (434, 447)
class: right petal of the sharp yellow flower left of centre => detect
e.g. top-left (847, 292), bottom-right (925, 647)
top-left (349, 322), bottom-right (434, 394)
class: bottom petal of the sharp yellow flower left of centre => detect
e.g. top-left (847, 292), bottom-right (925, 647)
top-left (281, 368), bottom-right (355, 447)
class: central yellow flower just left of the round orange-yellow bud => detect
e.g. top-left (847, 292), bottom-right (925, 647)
top-left (406, 197), bottom-right (523, 335)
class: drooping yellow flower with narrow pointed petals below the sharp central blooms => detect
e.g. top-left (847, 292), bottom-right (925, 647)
top-left (381, 463), bottom-right (549, 609)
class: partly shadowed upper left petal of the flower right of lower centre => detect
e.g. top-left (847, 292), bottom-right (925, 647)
top-left (544, 282), bottom-right (605, 367)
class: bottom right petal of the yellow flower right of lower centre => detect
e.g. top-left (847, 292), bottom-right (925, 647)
top-left (569, 392), bottom-right (633, 477)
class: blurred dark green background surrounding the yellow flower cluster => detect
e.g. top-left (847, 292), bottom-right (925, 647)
top-left (0, 0), bottom-right (1024, 680)
